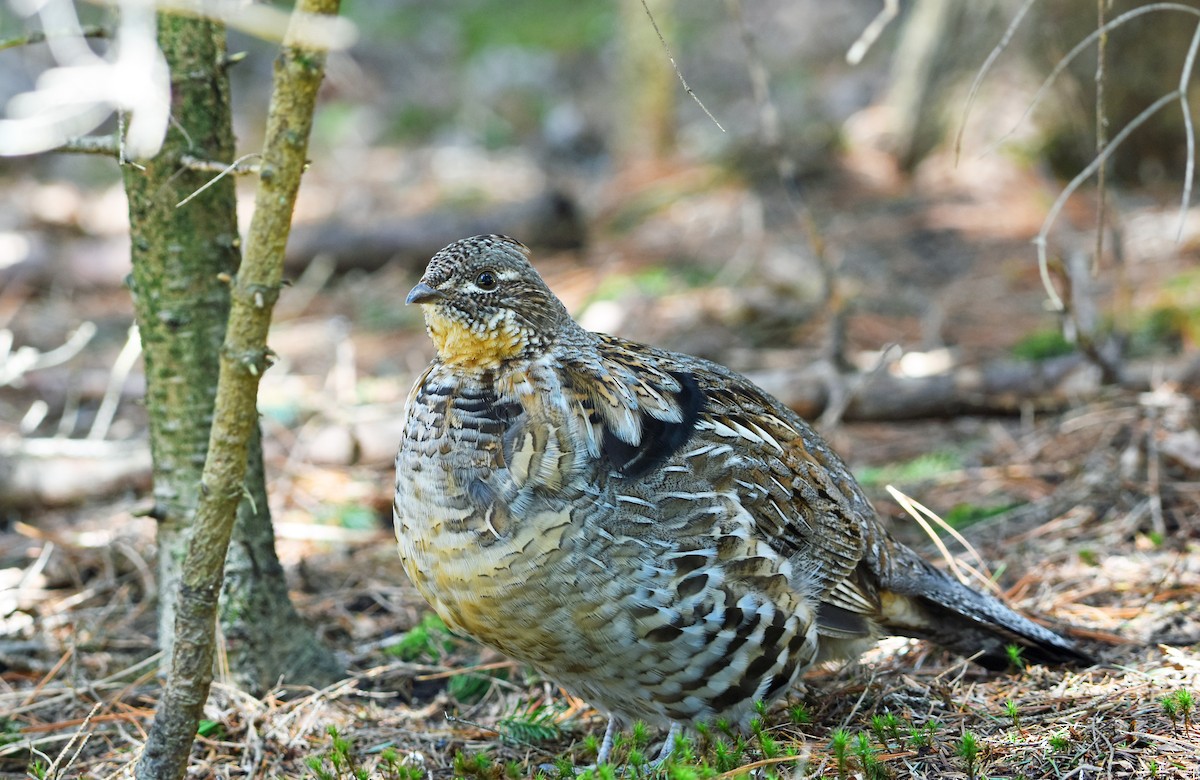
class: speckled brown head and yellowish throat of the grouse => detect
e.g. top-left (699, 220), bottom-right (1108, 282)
top-left (407, 235), bottom-right (578, 370)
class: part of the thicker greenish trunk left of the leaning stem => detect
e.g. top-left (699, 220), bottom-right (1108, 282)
top-left (124, 14), bottom-right (240, 672)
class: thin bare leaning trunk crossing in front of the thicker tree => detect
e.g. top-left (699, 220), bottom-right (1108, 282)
top-left (137, 0), bottom-right (338, 780)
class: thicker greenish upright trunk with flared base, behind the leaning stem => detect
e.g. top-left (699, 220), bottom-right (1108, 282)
top-left (125, 0), bottom-right (340, 692)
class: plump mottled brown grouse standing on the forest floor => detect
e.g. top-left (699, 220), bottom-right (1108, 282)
top-left (395, 236), bottom-right (1084, 753)
